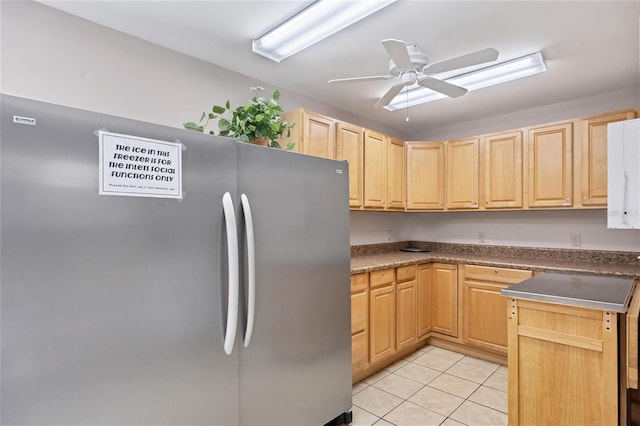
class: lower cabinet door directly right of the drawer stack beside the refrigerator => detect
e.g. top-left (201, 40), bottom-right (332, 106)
top-left (369, 285), bottom-right (396, 364)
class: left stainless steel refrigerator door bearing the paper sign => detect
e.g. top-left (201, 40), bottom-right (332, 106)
top-left (0, 96), bottom-right (239, 425)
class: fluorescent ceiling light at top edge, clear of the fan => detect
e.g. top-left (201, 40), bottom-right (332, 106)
top-left (253, 0), bottom-right (396, 62)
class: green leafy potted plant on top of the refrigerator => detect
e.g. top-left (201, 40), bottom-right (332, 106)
top-left (183, 86), bottom-right (295, 150)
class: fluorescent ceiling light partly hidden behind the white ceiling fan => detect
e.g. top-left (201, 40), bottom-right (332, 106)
top-left (385, 52), bottom-right (547, 111)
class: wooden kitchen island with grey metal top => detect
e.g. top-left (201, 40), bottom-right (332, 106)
top-left (502, 273), bottom-right (639, 425)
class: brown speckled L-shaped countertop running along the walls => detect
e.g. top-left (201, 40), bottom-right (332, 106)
top-left (351, 241), bottom-right (640, 277)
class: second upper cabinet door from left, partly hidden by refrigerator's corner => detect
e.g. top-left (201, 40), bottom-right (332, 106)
top-left (336, 123), bottom-right (364, 208)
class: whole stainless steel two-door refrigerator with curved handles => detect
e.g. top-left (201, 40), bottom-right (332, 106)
top-left (0, 95), bottom-right (351, 425)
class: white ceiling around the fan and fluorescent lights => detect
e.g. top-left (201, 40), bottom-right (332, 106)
top-left (42, 0), bottom-right (640, 134)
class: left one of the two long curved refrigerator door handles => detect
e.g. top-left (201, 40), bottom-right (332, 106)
top-left (222, 192), bottom-right (240, 355)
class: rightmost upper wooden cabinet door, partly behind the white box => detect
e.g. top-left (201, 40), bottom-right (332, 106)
top-left (578, 111), bottom-right (635, 206)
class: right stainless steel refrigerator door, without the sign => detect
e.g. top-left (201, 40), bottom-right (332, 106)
top-left (238, 145), bottom-right (351, 425)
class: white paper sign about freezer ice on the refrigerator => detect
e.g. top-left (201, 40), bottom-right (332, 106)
top-left (98, 130), bottom-right (182, 199)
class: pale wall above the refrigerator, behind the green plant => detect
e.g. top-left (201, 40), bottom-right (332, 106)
top-left (0, 1), bottom-right (404, 139)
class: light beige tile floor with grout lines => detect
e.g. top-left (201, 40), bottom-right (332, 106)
top-left (351, 346), bottom-right (507, 426)
